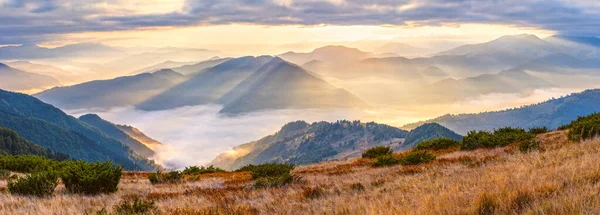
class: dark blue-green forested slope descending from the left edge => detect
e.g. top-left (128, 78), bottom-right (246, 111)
top-left (0, 90), bottom-right (157, 171)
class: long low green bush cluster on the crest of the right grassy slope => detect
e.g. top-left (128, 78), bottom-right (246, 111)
top-left (460, 127), bottom-right (534, 150)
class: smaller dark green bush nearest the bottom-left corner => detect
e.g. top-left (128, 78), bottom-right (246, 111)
top-left (8, 171), bottom-right (58, 197)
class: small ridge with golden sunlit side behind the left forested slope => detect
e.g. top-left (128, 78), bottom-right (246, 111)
top-left (79, 114), bottom-right (154, 158)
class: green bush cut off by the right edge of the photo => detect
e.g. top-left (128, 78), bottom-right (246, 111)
top-left (566, 113), bottom-right (600, 142)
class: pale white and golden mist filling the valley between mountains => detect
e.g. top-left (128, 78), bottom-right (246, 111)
top-left (67, 86), bottom-right (577, 169)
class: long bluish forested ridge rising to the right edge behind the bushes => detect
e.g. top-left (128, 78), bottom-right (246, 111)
top-left (403, 89), bottom-right (600, 134)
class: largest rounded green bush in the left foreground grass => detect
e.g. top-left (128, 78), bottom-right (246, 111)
top-left (61, 161), bottom-right (123, 195)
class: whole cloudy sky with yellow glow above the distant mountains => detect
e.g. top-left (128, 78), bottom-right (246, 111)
top-left (0, 0), bottom-right (600, 53)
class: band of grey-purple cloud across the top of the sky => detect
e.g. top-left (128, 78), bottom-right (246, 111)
top-left (0, 0), bottom-right (600, 43)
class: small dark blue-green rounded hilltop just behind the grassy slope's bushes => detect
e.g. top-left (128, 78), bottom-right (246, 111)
top-left (403, 123), bottom-right (462, 146)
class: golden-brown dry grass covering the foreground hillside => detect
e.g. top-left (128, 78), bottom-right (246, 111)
top-left (0, 131), bottom-right (600, 214)
